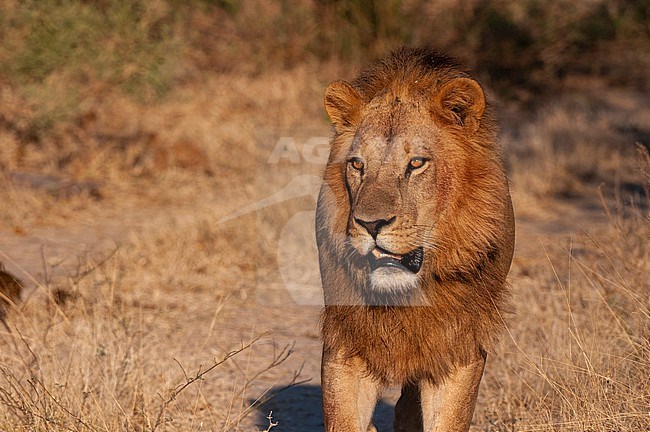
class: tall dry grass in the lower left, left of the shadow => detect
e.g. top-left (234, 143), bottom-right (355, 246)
top-left (0, 217), bottom-right (291, 431)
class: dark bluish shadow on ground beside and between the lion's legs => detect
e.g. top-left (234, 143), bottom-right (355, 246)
top-left (250, 385), bottom-right (394, 432)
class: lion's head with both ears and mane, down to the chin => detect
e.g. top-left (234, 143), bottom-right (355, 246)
top-left (317, 71), bottom-right (511, 302)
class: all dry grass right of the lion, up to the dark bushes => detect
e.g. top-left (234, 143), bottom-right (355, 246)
top-left (475, 96), bottom-right (650, 431)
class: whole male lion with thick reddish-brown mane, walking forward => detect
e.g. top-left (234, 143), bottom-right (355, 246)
top-left (316, 48), bottom-right (514, 432)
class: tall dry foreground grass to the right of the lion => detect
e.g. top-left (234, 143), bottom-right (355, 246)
top-left (475, 147), bottom-right (650, 432)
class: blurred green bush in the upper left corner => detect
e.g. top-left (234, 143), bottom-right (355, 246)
top-left (0, 0), bottom-right (183, 135)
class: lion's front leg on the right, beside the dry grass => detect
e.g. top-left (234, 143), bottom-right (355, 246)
top-left (420, 355), bottom-right (485, 432)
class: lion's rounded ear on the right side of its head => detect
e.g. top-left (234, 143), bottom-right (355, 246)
top-left (435, 78), bottom-right (485, 130)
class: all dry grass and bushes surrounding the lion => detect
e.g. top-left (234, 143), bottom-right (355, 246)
top-left (0, 0), bottom-right (650, 432)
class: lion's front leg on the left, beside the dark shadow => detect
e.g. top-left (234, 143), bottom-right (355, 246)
top-left (321, 349), bottom-right (380, 432)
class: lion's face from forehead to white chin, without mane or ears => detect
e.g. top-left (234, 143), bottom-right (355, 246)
top-left (345, 97), bottom-right (439, 292)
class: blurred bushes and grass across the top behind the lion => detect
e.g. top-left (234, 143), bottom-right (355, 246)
top-left (0, 0), bottom-right (650, 204)
